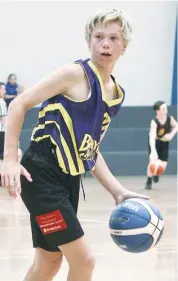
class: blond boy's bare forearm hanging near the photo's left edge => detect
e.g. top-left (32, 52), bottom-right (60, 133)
top-left (4, 100), bottom-right (25, 161)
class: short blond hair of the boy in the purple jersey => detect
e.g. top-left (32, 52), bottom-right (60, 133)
top-left (85, 9), bottom-right (132, 46)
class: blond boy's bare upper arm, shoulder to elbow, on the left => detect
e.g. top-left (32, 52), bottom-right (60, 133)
top-left (13, 63), bottom-right (84, 110)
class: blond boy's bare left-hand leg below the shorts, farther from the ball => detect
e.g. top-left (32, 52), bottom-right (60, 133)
top-left (24, 248), bottom-right (62, 281)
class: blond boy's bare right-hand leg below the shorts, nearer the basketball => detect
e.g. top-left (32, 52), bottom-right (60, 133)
top-left (60, 237), bottom-right (95, 281)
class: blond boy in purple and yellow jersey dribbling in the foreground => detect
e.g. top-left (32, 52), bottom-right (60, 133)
top-left (2, 10), bottom-right (148, 281)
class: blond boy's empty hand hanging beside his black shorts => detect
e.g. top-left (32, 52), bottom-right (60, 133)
top-left (1, 161), bottom-right (32, 198)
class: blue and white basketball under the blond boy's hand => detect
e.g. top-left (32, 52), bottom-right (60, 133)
top-left (109, 198), bottom-right (164, 253)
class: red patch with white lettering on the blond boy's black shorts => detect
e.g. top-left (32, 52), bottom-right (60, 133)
top-left (36, 210), bottom-right (67, 234)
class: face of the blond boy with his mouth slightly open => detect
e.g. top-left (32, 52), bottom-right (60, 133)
top-left (89, 23), bottom-right (126, 67)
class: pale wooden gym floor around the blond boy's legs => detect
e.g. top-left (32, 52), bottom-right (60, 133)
top-left (0, 176), bottom-right (177, 281)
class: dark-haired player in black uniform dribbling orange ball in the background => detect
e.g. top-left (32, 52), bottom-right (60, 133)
top-left (145, 101), bottom-right (178, 189)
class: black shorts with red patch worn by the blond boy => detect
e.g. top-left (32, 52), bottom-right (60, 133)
top-left (21, 144), bottom-right (84, 252)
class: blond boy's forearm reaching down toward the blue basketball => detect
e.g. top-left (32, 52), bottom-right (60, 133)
top-left (92, 152), bottom-right (125, 198)
